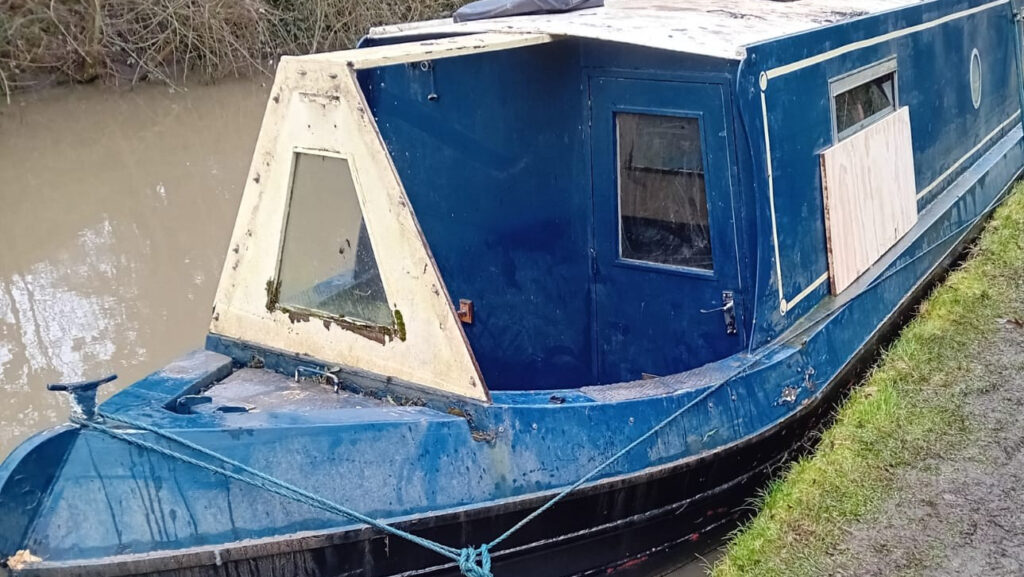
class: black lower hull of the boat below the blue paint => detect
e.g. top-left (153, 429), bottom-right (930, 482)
top-left (25, 210), bottom-right (981, 577)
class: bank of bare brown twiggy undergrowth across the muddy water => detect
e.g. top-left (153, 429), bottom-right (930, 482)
top-left (0, 0), bottom-right (462, 96)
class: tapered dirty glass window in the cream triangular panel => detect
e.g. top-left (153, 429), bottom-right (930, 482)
top-left (278, 152), bottom-right (394, 327)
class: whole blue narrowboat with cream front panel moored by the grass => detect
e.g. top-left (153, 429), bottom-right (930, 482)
top-left (0, 0), bottom-right (1024, 577)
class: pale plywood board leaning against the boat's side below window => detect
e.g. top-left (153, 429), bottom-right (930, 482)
top-left (821, 108), bottom-right (918, 294)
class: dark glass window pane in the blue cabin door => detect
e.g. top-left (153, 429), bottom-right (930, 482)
top-left (615, 112), bottom-right (713, 271)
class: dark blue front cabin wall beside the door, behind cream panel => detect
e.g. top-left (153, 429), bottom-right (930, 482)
top-left (359, 39), bottom-right (754, 389)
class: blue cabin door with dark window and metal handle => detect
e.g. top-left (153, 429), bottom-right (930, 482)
top-left (590, 77), bottom-right (744, 382)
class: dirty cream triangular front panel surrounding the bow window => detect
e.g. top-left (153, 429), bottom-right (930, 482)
top-left (210, 53), bottom-right (488, 401)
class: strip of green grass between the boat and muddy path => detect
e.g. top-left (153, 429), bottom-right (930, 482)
top-left (713, 184), bottom-right (1024, 577)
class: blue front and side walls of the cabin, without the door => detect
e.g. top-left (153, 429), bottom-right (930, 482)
top-left (352, 0), bottom-right (1020, 389)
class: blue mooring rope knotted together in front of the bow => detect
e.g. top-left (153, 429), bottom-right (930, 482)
top-left (71, 381), bottom-right (725, 577)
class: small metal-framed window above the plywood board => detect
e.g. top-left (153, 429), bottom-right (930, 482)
top-left (828, 56), bottom-right (899, 143)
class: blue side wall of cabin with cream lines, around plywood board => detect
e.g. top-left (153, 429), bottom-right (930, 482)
top-left (737, 1), bottom-right (1020, 347)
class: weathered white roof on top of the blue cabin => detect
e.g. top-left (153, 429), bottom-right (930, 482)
top-left (370, 0), bottom-right (925, 59)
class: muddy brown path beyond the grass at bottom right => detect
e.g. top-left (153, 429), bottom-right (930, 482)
top-left (823, 315), bottom-right (1024, 577)
